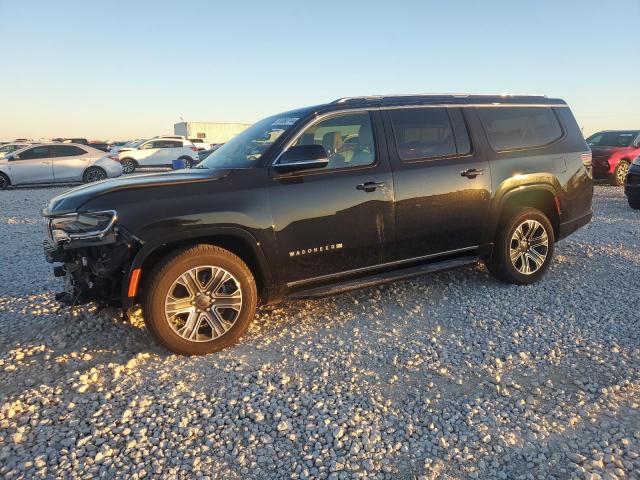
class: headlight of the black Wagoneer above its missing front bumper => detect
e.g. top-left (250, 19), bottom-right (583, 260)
top-left (49, 210), bottom-right (117, 243)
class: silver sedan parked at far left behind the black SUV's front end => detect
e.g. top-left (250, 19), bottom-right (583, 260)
top-left (0, 143), bottom-right (122, 190)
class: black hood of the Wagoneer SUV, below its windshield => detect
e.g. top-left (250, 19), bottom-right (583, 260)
top-left (42, 168), bottom-right (231, 217)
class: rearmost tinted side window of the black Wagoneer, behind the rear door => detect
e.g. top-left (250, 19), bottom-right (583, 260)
top-left (478, 107), bottom-right (562, 152)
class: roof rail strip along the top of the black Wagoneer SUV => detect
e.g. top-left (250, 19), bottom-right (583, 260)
top-left (331, 93), bottom-right (566, 105)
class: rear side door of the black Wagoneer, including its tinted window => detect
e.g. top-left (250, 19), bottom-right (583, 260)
top-left (384, 106), bottom-right (491, 260)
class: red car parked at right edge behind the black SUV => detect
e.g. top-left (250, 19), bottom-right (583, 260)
top-left (587, 130), bottom-right (640, 186)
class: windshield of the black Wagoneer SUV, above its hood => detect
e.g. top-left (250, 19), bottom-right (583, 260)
top-left (199, 111), bottom-right (301, 168)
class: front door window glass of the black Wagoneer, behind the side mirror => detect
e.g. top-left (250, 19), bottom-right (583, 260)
top-left (295, 112), bottom-right (376, 170)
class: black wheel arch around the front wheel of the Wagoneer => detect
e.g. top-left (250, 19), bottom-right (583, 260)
top-left (121, 227), bottom-right (271, 307)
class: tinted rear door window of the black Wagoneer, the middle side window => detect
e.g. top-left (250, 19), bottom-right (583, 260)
top-left (389, 107), bottom-right (458, 161)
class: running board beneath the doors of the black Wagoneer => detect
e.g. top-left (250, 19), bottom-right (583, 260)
top-left (289, 255), bottom-right (480, 299)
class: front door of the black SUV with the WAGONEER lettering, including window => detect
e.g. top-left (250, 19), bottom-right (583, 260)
top-left (269, 111), bottom-right (394, 287)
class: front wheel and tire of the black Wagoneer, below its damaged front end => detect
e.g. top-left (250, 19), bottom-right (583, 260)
top-left (142, 245), bottom-right (258, 355)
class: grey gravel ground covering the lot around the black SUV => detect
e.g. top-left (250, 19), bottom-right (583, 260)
top-left (0, 186), bottom-right (640, 479)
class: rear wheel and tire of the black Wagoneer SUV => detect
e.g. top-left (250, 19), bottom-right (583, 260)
top-left (487, 208), bottom-right (555, 285)
